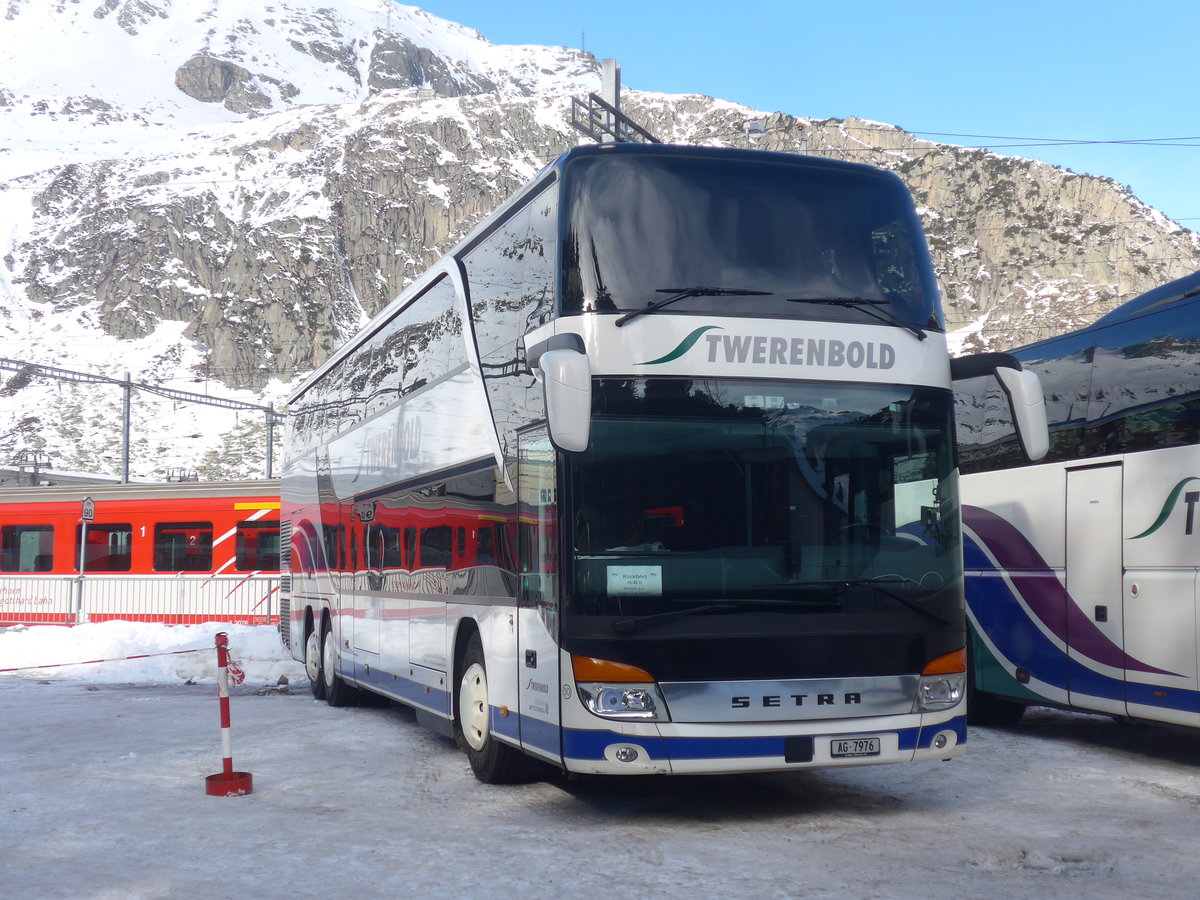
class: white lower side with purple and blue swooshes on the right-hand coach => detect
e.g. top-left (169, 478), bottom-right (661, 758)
top-left (962, 448), bottom-right (1200, 726)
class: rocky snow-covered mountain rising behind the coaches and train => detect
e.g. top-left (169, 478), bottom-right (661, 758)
top-left (0, 0), bottom-right (1200, 478)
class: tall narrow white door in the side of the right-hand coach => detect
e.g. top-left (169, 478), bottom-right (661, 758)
top-left (1067, 463), bottom-right (1126, 715)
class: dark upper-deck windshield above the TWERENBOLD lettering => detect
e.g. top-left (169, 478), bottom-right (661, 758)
top-left (562, 155), bottom-right (941, 329)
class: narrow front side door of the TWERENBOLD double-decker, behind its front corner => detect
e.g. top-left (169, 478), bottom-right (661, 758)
top-left (517, 428), bottom-right (562, 760)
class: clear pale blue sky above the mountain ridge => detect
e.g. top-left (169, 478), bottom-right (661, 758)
top-left (412, 0), bottom-right (1200, 230)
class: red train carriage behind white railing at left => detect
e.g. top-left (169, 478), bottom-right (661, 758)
top-left (0, 481), bottom-right (280, 625)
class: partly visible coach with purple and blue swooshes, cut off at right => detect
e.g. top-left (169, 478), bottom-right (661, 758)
top-left (960, 272), bottom-right (1200, 726)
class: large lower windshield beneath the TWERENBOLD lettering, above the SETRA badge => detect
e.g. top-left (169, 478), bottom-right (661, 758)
top-left (566, 378), bottom-right (961, 630)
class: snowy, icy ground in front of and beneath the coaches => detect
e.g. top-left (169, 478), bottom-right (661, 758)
top-left (0, 623), bottom-right (1200, 900)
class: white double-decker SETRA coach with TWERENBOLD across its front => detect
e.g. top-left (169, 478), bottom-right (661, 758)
top-left (282, 144), bottom-right (1040, 782)
